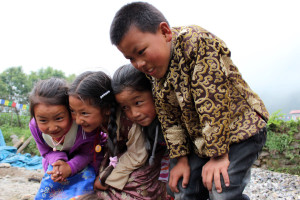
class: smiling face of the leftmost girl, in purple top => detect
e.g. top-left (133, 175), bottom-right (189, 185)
top-left (33, 103), bottom-right (72, 138)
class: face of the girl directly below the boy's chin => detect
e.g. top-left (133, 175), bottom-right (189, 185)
top-left (115, 89), bottom-right (156, 126)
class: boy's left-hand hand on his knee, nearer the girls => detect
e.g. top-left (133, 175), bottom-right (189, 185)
top-left (169, 156), bottom-right (190, 193)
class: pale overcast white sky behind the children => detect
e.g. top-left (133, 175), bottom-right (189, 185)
top-left (0, 0), bottom-right (300, 112)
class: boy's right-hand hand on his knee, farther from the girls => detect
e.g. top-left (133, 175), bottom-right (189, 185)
top-left (202, 154), bottom-right (230, 193)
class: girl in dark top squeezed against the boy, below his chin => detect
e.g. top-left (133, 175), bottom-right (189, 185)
top-left (112, 64), bottom-right (169, 182)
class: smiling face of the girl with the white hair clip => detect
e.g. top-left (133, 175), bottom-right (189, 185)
top-left (69, 96), bottom-right (105, 132)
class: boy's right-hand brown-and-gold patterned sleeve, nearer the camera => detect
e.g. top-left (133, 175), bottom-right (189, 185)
top-left (191, 38), bottom-right (233, 157)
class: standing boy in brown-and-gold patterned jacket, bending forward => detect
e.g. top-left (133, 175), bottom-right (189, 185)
top-left (110, 2), bottom-right (269, 199)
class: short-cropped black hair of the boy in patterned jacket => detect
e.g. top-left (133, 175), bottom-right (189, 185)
top-left (110, 2), bottom-right (169, 45)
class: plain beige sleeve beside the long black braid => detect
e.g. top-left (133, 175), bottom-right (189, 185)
top-left (105, 124), bottom-right (148, 190)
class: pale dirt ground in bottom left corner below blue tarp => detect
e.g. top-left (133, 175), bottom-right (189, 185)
top-left (0, 167), bottom-right (44, 200)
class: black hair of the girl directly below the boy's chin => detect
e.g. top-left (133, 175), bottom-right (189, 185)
top-left (112, 64), bottom-right (152, 94)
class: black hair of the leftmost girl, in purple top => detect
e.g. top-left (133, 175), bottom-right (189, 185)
top-left (29, 78), bottom-right (70, 118)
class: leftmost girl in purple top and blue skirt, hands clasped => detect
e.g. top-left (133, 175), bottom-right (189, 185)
top-left (29, 78), bottom-right (106, 199)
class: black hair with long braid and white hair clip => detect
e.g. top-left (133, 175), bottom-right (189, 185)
top-left (69, 71), bottom-right (118, 182)
